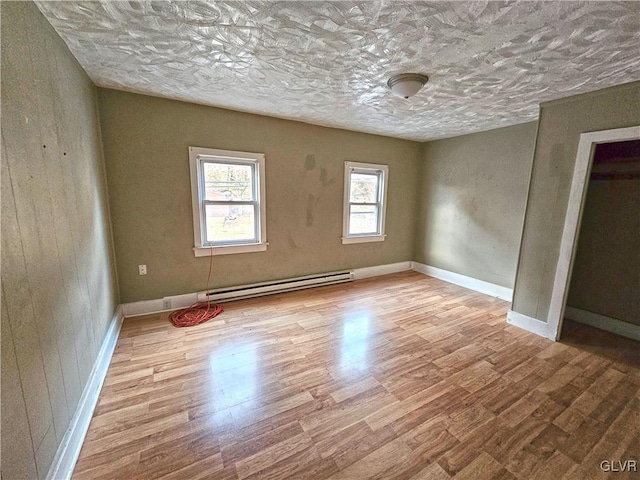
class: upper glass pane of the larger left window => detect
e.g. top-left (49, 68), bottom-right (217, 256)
top-left (202, 162), bottom-right (255, 201)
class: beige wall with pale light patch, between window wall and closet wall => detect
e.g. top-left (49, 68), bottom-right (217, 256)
top-left (415, 122), bottom-right (537, 287)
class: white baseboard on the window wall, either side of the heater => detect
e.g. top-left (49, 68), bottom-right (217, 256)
top-left (121, 261), bottom-right (413, 318)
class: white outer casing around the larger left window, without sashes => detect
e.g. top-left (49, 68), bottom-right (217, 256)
top-left (189, 147), bottom-right (269, 257)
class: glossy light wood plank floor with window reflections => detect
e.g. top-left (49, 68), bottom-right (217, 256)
top-left (74, 272), bottom-right (640, 480)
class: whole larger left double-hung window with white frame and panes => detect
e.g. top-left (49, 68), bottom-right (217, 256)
top-left (189, 147), bottom-right (267, 257)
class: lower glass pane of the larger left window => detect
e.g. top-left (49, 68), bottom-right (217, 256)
top-left (205, 205), bottom-right (258, 243)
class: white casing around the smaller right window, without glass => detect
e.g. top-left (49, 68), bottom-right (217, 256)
top-left (341, 162), bottom-right (389, 244)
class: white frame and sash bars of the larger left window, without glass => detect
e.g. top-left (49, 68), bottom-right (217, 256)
top-left (189, 147), bottom-right (269, 257)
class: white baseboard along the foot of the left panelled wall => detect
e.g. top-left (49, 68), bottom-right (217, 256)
top-left (46, 306), bottom-right (124, 480)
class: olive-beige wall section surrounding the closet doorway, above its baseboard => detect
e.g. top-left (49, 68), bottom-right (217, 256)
top-left (512, 82), bottom-right (640, 322)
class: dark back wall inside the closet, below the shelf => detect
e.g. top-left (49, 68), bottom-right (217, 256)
top-left (567, 174), bottom-right (640, 325)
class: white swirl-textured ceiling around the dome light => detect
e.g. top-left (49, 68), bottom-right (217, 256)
top-left (37, 1), bottom-right (640, 140)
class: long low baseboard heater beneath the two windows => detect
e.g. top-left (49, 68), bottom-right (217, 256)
top-left (198, 270), bottom-right (353, 302)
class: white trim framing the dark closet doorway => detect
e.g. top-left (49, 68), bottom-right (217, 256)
top-left (547, 125), bottom-right (640, 341)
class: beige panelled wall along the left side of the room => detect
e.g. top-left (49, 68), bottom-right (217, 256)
top-left (1, 2), bottom-right (117, 480)
